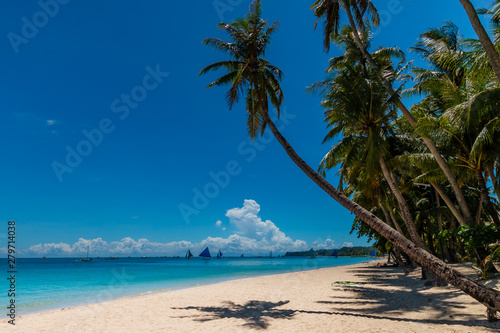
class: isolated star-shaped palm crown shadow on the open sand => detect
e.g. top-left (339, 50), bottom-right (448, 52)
top-left (172, 301), bottom-right (296, 329)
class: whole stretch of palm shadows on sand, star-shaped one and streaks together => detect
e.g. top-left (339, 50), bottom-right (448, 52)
top-left (173, 267), bottom-right (498, 331)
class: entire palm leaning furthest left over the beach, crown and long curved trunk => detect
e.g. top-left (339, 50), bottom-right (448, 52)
top-left (200, 0), bottom-right (500, 318)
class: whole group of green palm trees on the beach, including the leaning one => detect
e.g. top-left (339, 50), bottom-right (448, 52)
top-left (200, 0), bottom-right (500, 320)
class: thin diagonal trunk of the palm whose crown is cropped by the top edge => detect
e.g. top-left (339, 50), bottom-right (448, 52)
top-left (344, 0), bottom-right (472, 224)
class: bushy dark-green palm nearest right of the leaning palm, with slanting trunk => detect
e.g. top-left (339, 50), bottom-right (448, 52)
top-left (309, 42), bottom-right (422, 246)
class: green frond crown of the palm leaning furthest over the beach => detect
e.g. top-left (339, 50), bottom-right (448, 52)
top-left (199, 0), bottom-right (283, 139)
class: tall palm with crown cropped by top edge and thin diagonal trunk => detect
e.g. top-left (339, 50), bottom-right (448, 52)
top-left (312, 0), bottom-right (472, 224)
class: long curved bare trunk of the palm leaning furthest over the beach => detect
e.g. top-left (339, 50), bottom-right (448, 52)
top-left (262, 110), bottom-right (500, 320)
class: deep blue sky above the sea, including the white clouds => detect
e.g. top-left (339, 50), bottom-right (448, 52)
top-left (0, 0), bottom-right (489, 256)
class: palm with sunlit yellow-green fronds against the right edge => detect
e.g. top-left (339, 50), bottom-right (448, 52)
top-left (408, 22), bottom-right (500, 224)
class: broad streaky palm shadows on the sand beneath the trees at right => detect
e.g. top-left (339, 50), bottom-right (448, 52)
top-left (316, 267), bottom-right (498, 328)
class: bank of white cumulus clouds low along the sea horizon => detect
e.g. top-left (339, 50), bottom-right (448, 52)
top-left (23, 200), bottom-right (320, 257)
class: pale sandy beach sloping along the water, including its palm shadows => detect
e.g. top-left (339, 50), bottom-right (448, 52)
top-left (0, 262), bottom-right (500, 333)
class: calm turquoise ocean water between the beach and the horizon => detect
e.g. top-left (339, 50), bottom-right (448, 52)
top-left (0, 257), bottom-right (370, 315)
